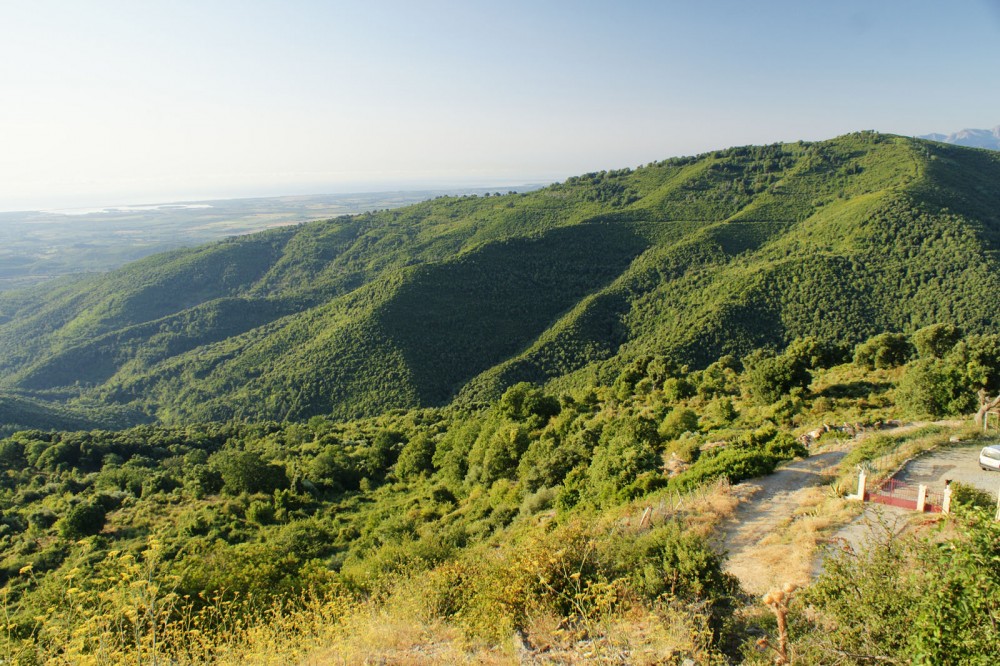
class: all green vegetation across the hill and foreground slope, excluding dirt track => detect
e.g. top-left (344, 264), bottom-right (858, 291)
top-left (0, 132), bottom-right (1000, 664)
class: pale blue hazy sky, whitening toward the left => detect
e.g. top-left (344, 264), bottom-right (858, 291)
top-left (0, 0), bottom-right (1000, 210)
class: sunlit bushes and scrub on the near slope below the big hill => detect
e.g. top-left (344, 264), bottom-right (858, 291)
top-left (0, 324), bottom-right (1000, 664)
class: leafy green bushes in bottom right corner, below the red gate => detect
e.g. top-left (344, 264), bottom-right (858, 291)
top-left (793, 511), bottom-right (1000, 665)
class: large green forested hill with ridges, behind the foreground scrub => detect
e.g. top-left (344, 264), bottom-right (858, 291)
top-left (0, 133), bottom-right (1000, 427)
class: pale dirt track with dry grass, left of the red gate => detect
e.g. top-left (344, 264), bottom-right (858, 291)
top-left (722, 442), bottom-right (850, 595)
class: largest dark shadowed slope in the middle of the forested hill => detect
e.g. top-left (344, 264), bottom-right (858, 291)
top-left (380, 223), bottom-right (647, 404)
